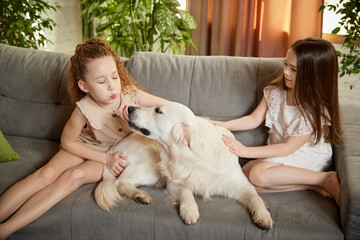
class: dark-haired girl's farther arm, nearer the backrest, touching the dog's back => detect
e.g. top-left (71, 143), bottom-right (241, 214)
top-left (211, 97), bottom-right (268, 131)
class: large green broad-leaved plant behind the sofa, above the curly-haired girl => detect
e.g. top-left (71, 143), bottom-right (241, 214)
top-left (81, 0), bottom-right (197, 57)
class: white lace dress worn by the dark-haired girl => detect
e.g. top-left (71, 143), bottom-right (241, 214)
top-left (243, 86), bottom-right (332, 171)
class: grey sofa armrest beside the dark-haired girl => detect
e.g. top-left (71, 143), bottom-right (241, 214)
top-left (334, 104), bottom-right (360, 239)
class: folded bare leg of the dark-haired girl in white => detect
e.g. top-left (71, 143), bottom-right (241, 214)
top-left (245, 164), bottom-right (340, 205)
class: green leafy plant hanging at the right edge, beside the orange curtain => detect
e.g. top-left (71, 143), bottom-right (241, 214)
top-left (319, 0), bottom-right (360, 89)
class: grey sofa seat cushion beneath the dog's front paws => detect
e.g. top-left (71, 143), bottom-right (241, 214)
top-left (62, 185), bottom-right (343, 240)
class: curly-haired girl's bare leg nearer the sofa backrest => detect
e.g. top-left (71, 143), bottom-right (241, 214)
top-left (0, 150), bottom-right (84, 223)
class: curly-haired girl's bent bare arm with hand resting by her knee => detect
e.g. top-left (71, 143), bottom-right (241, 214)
top-left (61, 107), bottom-right (127, 176)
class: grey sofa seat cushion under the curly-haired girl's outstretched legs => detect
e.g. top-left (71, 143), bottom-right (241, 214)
top-left (0, 135), bottom-right (73, 240)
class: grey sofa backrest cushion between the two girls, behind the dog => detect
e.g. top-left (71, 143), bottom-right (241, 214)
top-left (127, 52), bottom-right (283, 146)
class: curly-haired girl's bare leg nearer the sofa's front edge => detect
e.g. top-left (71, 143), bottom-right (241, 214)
top-left (0, 161), bottom-right (103, 239)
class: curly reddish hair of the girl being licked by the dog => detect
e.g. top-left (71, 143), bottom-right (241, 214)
top-left (67, 37), bottom-right (140, 102)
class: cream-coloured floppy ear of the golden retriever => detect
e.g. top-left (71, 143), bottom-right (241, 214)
top-left (172, 123), bottom-right (204, 155)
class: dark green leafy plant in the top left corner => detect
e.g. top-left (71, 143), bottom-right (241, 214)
top-left (0, 0), bottom-right (61, 49)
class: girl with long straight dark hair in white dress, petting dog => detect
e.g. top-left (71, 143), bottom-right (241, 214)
top-left (212, 38), bottom-right (341, 205)
